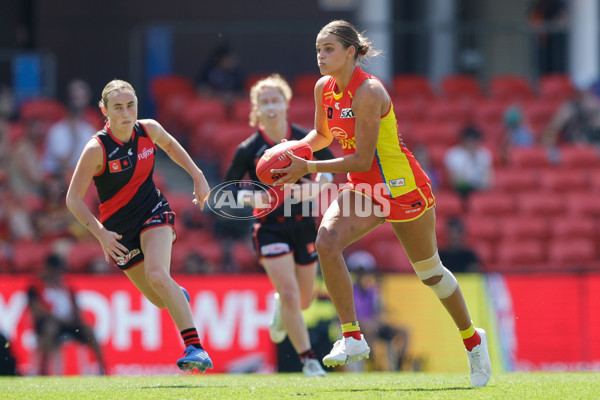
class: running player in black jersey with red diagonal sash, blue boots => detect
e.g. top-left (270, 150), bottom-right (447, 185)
top-left (67, 80), bottom-right (213, 372)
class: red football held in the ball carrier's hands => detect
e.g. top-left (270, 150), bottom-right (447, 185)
top-left (256, 140), bottom-right (312, 185)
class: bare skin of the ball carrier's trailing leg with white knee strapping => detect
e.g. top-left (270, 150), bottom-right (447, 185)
top-left (392, 208), bottom-right (471, 330)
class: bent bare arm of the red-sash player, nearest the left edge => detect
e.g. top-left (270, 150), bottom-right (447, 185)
top-left (67, 138), bottom-right (129, 262)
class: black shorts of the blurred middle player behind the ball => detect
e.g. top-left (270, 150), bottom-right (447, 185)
top-left (254, 218), bottom-right (318, 265)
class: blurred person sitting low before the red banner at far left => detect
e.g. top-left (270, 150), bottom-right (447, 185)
top-left (28, 254), bottom-right (106, 375)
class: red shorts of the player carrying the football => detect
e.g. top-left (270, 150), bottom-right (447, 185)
top-left (339, 182), bottom-right (435, 222)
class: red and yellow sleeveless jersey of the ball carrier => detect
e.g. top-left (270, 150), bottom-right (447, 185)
top-left (323, 67), bottom-right (429, 198)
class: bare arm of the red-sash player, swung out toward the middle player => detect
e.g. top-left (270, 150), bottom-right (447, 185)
top-left (140, 119), bottom-right (210, 210)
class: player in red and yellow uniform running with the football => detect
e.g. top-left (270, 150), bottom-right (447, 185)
top-left (274, 21), bottom-right (491, 386)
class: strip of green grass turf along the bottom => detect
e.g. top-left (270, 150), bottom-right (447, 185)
top-left (0, 373), bottom-right (600, 400)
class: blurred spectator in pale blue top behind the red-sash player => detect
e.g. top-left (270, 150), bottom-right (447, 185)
top-left (42, 79), bottom-right (97, 175)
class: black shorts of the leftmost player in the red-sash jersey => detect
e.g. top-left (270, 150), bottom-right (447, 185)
top-left (116, 196), bottom-right (177, 271)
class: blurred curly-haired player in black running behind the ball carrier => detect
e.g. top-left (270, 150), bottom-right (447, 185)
top-left (225, 74), bottom-right (333, 376)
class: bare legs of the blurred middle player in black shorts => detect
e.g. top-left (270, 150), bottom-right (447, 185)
top-left (261, 254), bottom-right (316, 354)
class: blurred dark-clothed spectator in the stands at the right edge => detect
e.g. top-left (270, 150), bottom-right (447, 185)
top-left (542, 83), bottom-right (600, 148)
